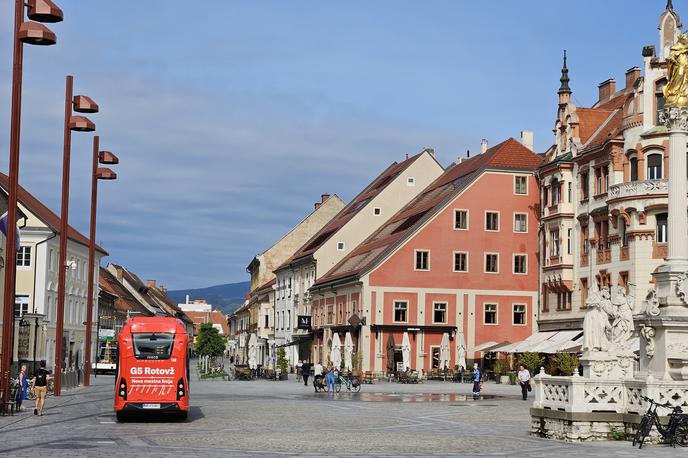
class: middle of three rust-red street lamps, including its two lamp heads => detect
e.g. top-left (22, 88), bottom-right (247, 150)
top-left (53, 75), bottom-right (98, 396)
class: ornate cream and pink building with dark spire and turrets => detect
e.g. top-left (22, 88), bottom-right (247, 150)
top-left (539, 4), bottom-right (681, 331)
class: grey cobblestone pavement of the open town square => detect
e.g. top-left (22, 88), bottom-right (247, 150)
top-left (0, 376), bottom-right (688, 457)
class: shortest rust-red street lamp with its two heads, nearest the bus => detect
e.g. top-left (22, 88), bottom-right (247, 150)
top-left (84, 135), bottom-right (119, 386)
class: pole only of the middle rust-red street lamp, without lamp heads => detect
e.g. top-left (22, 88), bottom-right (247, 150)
top-left (53, 75), bottom-right (74, 396)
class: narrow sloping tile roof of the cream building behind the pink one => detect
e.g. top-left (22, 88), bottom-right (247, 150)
top-left (276, 151), bottom-right (425, 270)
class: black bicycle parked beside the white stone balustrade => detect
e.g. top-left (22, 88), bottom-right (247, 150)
top-left (633, 396), bottom-right (688, 449)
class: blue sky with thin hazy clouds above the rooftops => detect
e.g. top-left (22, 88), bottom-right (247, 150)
top-left (0, 0), bottom-right (676, 288)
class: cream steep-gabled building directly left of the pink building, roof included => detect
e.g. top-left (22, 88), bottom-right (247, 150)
top-left (275, 149), bottom-right (444, 366)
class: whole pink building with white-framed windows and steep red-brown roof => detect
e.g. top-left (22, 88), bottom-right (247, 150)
top-left (310, 138), bottom-right (541, 372)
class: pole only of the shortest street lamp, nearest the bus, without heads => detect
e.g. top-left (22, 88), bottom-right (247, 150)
top-left (84, 135), bottom-right (100, 386)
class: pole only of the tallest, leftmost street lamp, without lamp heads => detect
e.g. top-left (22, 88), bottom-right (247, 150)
top-left (0, 0), bottom-right (24, 405)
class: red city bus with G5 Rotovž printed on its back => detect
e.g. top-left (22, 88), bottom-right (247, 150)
top-left (115, 317), bottom-right (189, 421)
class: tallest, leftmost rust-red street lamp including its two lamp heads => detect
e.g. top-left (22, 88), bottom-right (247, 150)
top-left (0, 0), bottom-right (63, 405)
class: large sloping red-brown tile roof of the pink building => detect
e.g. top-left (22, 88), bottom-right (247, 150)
top-left (314, 138), bottom-right (542, 286)
